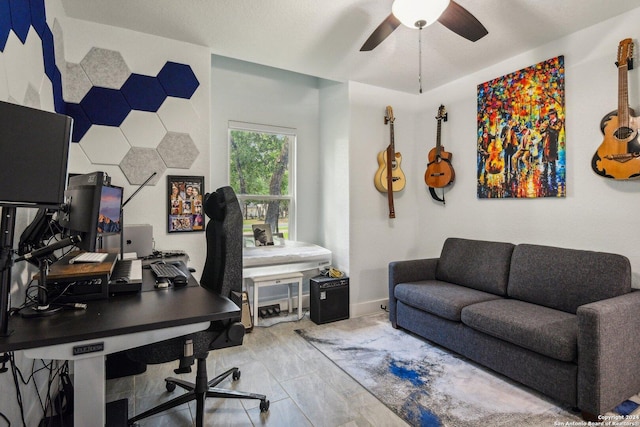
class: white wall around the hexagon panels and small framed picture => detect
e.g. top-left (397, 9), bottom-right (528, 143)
top-left (60, 17), bottom-right (212, 271)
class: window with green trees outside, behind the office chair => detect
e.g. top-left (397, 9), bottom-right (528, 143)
top-left (229, 122), bottom-right (296, 240)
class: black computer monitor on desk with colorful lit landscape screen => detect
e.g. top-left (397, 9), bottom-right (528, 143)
top-left (58, 174), bottom-right (122, 252)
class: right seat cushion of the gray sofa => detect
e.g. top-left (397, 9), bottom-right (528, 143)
top-left (462, 299), bottom-right (578, 362)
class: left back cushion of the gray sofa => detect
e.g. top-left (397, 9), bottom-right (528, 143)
top-left (436, 237), bottom-right (514, 295)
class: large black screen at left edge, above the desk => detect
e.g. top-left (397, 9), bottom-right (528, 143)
top-left (0, 101), bottom-right (72, 207)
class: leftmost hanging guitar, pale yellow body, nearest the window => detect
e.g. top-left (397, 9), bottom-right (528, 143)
top-left (373, 105), bottom-right (406, 218)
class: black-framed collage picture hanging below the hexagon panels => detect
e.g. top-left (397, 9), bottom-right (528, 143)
top-left (167, 175), bottom-right (205, 233)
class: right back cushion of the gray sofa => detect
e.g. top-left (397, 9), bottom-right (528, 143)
top-left (507, 244), bottom-right (631, 314)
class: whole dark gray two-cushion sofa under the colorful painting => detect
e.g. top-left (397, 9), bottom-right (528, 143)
top-left (389, 238), bottom-right (640, 419)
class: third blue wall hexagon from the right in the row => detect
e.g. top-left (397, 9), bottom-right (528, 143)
top-left (80, 86), bottom-right (131, 126)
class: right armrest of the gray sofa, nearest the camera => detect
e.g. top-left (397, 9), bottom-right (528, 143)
top-left (577, 291), bottom-right (640, 415)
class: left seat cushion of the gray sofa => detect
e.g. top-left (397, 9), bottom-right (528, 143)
top-left (394, 280), bottom-right (500, 322)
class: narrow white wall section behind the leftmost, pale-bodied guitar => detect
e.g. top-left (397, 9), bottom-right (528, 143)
top-left (349, 82), bottom-right (427, 316)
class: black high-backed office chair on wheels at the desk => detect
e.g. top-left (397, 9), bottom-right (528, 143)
top-left (127, 187), bottom-right (269, 427)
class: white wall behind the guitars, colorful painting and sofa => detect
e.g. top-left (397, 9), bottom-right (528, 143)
top-left (350, 5), bottom-right (640, 314)
